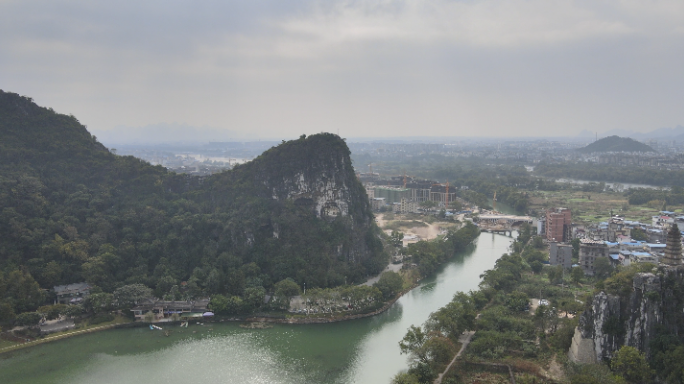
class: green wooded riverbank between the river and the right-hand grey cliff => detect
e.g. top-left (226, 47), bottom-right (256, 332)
top-left (392, 222), bottom-right (656, 384)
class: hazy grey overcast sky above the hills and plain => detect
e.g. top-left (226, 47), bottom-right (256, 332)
top-left (0, 0), bottom-right (684, 137)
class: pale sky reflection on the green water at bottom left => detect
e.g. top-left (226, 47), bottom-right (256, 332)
top-left (63, 334), bottom-right (307, 384)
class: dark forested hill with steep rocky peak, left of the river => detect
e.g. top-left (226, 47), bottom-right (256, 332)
top-left (0, 91), bottom-right (386, 320)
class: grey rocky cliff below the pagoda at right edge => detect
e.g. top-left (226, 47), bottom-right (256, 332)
top-left (570, 266), bottom-right (684, 362)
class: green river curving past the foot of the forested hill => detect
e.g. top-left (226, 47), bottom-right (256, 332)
top-left (0, 233), bottom-right (513, 384)
